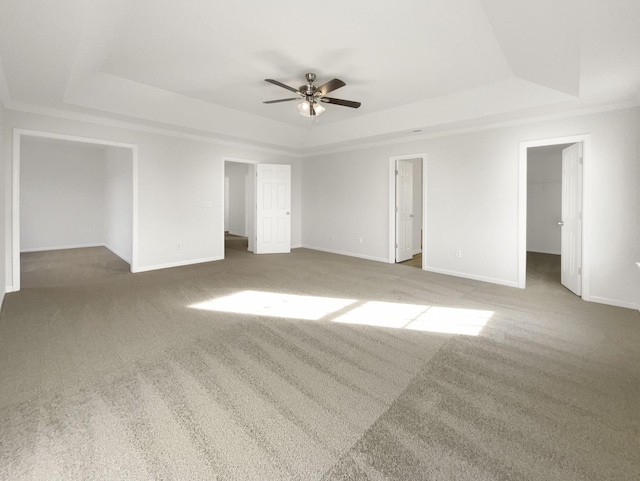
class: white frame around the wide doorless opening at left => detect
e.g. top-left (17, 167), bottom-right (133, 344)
top-left (6, 128), bottom-right (138, 292)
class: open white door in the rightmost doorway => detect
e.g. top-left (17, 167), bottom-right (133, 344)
top-left (559, 142), bottom-right (582, 295)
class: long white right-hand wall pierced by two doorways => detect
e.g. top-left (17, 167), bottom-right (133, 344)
top-left (302, 109), bottom-right (639, 307)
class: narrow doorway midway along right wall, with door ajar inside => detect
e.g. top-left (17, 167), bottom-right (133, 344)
top-left (389, 153), bottom-right (426, 269)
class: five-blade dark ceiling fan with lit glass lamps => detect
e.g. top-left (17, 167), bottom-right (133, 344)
top-left (263, 73), bottom-right (361, 117)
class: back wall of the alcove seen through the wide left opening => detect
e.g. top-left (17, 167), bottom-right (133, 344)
top-left (20, 138), bottom-right (105, 252)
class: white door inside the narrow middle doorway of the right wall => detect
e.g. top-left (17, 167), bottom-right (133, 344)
top-left (396, 160), bottom-right (413, 262)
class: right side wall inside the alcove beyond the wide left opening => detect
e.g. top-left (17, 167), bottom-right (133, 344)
top-left (103, 147), bottom-right (133, 264)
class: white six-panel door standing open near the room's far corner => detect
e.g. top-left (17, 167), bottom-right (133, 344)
top-left (255, 164), bottom-right (291, 254)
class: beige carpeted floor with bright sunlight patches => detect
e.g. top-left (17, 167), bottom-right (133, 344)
top-left (0, 246), bottom-right (640, 481)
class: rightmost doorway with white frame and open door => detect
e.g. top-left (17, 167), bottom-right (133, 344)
top-left (519, 135), bottom-right (590, 300)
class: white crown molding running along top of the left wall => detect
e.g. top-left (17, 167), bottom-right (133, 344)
top-left (5, 102), bottom-right (300, 158)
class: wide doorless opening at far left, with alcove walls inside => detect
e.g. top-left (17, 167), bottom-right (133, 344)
top-left (7, 129), bottom-right (138, 292)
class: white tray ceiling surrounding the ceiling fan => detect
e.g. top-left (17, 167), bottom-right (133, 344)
top-left (0, 0), bottom-right (640, 152)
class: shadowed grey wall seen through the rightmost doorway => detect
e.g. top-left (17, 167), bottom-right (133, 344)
top-left (527, 148), bottom-right (562, 255)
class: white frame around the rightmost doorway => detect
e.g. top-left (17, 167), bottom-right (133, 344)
top-left (518, 134), bottom-right (591, 301)
